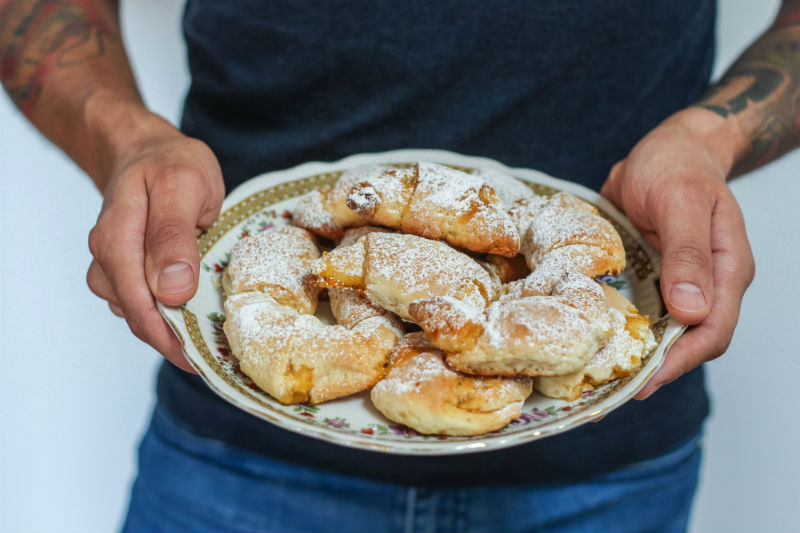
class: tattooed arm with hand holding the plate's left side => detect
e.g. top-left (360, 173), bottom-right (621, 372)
top-left (0, 0), bottom-right (224, 370)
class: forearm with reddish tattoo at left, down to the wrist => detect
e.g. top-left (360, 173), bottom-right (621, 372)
top-left (0, 0), bottom-right (176, 190)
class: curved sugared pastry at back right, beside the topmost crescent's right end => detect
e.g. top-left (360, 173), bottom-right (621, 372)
top-left (509, 192), bottom-right (625, 275)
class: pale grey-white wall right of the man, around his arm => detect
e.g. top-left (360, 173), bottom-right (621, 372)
top-left (692, 0), bottom-right (800, 532)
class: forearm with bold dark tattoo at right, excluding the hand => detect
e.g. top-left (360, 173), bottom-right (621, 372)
top-left (694, 0), bottom-right (800, 175)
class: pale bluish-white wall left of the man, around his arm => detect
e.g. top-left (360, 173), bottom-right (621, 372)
top-left (0, 0), bottom-right (188, 532)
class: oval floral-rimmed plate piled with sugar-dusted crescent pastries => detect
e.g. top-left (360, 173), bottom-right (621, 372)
top-left (160, 150), bottom-right (683, 455)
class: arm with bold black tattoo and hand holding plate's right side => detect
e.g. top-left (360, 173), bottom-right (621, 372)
top-left (602, 0), bottom-right (800, 399)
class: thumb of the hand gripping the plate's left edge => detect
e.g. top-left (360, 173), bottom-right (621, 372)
top-left (145, 170), bottom-right (205, 305)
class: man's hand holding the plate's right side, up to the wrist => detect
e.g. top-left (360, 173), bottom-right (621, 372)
top-left (601, 109), bottom-right (755, 399)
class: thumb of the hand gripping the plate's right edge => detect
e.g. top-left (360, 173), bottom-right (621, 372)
top-left (655, 183), bottom-right (715, 324)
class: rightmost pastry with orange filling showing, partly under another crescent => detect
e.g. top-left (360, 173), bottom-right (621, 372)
top-left (533, 285), bottom-right (656, 401)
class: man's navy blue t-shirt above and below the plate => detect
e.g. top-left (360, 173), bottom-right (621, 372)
top-left (158, 0), bottom-right (715, 485)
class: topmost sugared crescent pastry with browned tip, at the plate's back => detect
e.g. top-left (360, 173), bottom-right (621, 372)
top-left (347, 162), bottom-right (519, 257)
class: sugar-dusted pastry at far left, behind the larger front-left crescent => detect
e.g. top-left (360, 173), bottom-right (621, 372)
top-left (222, 226), bottom-right (319, 313)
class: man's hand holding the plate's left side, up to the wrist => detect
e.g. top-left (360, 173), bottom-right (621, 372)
top-left (86, 125), bottom-right (225, 372)
